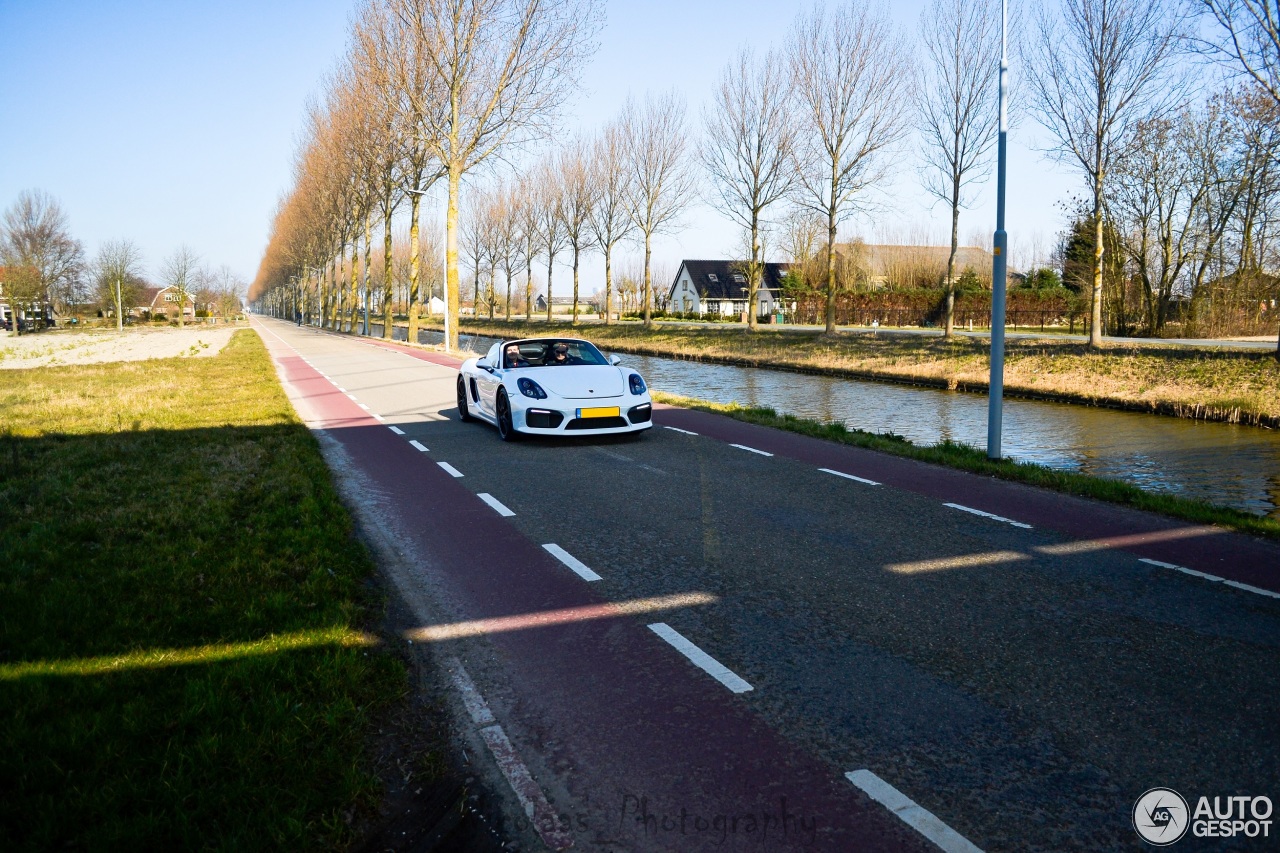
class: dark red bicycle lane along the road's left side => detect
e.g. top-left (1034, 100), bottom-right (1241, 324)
top-left (254, 322), bottom-right (932, 850)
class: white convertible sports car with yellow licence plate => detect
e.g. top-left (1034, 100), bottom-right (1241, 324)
top-left (458, 338), bottom-right (653, 442)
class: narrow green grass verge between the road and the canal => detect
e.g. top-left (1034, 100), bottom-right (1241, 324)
top-left (652, 392), bottom-right (1280, 539)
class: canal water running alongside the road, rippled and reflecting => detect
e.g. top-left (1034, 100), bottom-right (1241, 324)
top-left (378, 322), bottom-right (1280, 517)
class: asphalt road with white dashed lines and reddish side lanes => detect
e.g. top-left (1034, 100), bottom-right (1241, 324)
top-left (255, 319), bottom-right (1280, 850)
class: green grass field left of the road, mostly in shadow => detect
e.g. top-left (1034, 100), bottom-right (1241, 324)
top-left (0, 332), bottom-right (407, 850)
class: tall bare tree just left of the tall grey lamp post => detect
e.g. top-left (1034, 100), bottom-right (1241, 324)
top-left (916, 0), bottom-right (1000, 338)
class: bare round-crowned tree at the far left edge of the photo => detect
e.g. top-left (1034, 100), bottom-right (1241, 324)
top-left (0, 190), bottom-right (84, 336)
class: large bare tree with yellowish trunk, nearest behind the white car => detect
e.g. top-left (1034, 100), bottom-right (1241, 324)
top-left (384, 0), bottom-right (602, 350)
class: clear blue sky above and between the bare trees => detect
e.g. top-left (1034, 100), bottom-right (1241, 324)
top-left (0, 0), bottom-right (1079, 292)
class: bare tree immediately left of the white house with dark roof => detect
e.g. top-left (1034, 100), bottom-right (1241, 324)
top-left (622, 92), bottom-right (694, 328)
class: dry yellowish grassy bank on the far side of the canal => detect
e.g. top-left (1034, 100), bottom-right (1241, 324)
top-left (448, 321), bottom-right (1280, 428)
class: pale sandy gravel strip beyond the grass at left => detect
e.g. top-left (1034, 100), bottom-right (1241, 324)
top-left (0, 325), bottom-right (242, 370)
